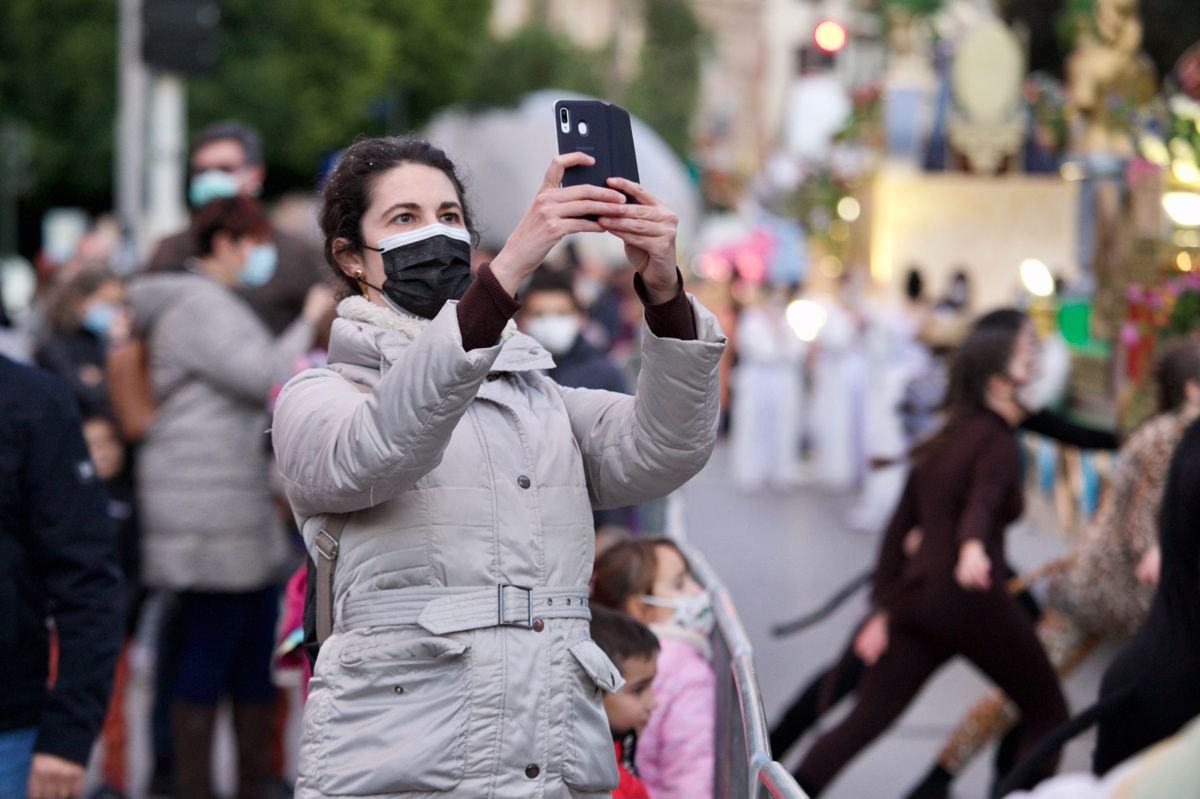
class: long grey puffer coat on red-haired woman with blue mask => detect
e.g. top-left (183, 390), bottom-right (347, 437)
top-left (128, 272), bottom-right (312, 593)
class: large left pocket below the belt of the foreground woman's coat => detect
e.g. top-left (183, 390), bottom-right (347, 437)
top-left (312, 638), bottom-right (472, 795)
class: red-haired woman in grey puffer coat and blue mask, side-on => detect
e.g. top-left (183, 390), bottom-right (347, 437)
top-left (128, 197), bottom-right (332, 797)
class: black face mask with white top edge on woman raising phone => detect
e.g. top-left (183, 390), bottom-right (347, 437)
top-left (364, 224), bottom-right (470, 319)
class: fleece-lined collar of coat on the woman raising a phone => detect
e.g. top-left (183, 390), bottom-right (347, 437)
top-left (329, 296), bottom-right (554, 386)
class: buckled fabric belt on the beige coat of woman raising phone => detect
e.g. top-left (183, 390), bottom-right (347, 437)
top-left (338, 583), bottom-right (592, 636)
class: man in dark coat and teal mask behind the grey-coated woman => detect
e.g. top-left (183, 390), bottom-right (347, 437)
top-left (148, 121), bottom-right (324, 335)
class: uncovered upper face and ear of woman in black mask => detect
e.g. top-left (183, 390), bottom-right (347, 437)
top-left (341, 163), bottom-right (466, 294)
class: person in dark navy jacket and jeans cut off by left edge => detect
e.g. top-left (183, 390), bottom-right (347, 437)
top-left (0, 356), bottom-right (124, 799)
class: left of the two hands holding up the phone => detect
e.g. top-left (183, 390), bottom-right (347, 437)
top-left (491, 152), bottom-right (625, 295)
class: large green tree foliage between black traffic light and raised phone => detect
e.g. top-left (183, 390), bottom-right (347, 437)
top-left (188, 0), bottom-right (491, 187)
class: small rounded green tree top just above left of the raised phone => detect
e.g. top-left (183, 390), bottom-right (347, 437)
top-left (467, 23), bottom-right (604, 107)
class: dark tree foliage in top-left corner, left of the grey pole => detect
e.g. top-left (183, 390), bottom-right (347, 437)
top-left (0, 0), bottom-right (116, 209)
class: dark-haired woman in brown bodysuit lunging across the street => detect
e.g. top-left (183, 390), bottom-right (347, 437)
top-left (796, 321), bottom-right (1067, 797)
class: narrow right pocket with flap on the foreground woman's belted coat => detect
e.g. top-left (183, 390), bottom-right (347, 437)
top-left (563, 638), bottom-right (624, 791)
